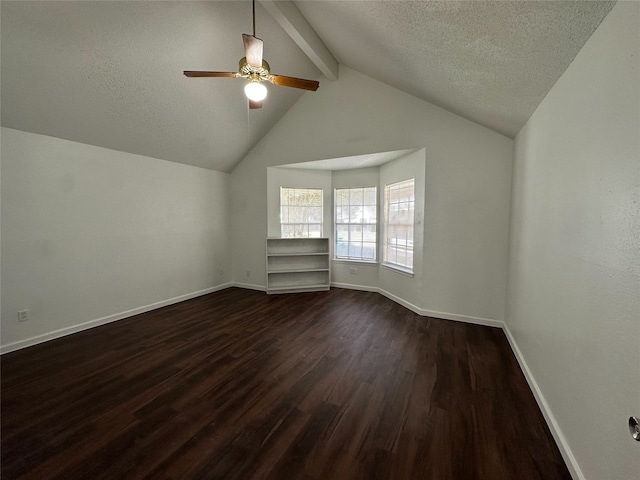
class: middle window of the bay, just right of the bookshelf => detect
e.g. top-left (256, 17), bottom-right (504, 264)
top-left (335, 187), bottom-right (377, 262)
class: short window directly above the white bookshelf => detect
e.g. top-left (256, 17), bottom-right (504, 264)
top-left (280, 187), bottom-right (322, 238)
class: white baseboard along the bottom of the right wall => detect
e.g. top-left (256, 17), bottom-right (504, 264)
top-left (502, 323), bottom-right (586, 480)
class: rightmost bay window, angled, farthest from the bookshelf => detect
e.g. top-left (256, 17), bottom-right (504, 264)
top-left (383, 178), bottom-right (415, 271)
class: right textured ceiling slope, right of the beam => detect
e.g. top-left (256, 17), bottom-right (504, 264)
top-left (295, 0), bottom-right (615, 138)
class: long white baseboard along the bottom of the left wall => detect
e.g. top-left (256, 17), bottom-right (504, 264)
top-left (0, 282), bottom-right (233, 355)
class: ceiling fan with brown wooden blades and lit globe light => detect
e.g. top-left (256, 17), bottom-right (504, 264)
top-left (183, 0), bottom-right (320, 109)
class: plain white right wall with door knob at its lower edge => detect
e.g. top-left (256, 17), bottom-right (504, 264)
top-left (506, 2), bottom-right (640, 480)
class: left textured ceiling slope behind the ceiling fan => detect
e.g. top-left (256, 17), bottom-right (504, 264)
top-left (1, 1), bottom-right (320, 171)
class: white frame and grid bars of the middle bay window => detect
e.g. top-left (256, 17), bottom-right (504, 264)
top-left (333, 185), bottom-right (380, 264)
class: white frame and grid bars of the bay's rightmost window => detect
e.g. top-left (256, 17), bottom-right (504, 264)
top-left (382, 177), bottom-right (416, 275)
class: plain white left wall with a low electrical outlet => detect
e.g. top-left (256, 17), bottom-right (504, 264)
top-left (1, 128), bottom-right (231, 351)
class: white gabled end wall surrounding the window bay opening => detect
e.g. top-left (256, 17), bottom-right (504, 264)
top-left (231, 66), bottom-right (513, 320)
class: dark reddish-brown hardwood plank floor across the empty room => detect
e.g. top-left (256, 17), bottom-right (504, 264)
top-left (0, 288), bottom-right (571, 480)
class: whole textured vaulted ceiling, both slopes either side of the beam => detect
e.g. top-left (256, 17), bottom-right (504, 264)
top-left (0, 0), bottom-right (615, 171)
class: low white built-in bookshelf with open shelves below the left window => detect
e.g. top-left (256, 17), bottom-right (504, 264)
top-left (267, 238), bottom-right (331, 293)
